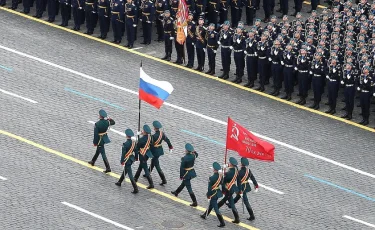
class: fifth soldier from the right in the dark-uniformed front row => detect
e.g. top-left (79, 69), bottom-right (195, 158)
top-left (294, 48), bottom-right (311, 105)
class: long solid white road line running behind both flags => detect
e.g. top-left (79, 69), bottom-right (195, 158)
top-left (0, 45), bottom-right (375, 179)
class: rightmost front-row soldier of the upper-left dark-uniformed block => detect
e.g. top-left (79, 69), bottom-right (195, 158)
top-left (125, 0), bottom-right (138, 49)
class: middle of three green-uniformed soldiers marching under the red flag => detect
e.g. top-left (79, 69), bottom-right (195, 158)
top-left (218, 157), bottom-right (241, 224)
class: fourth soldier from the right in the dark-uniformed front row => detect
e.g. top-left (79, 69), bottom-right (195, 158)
top-left (309, 53), bottom-right (326, 110)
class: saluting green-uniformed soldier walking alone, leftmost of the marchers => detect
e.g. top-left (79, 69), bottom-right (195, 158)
top-left (88, 109), bottom-right (115, 173)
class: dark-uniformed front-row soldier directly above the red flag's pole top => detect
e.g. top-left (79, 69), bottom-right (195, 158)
top-left (218, 21), bottom-right (233, 80)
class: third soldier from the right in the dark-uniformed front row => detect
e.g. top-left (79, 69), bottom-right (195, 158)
top-left (325, 58), bottom-right (342, 114)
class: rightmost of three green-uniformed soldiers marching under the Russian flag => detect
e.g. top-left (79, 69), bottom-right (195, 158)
top-left (150, 121), bottom-right (173, 185)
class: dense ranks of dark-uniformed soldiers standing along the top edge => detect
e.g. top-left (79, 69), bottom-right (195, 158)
top-left (1, 0), bottom-right (375, 125)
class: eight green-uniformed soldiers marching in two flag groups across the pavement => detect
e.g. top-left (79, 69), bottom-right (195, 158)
top-left (88, 110), bottom-right (258, 227)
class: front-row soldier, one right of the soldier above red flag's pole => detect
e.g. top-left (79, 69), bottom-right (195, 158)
top-left (232, 26), bottom-right (246, 84)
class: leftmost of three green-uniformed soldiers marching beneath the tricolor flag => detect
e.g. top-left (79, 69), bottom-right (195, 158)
top-left (115, 129), bottom-right (138, 194)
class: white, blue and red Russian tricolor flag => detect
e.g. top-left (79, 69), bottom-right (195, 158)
top-left (139, 67), bottom-right (173, 109)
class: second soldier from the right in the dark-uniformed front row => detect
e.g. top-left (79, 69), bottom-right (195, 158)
top-left (341, 63), bottom-right (358, 120)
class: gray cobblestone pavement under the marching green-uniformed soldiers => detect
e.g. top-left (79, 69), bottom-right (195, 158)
top-left (0, 11), bottom-right (375, 229)
